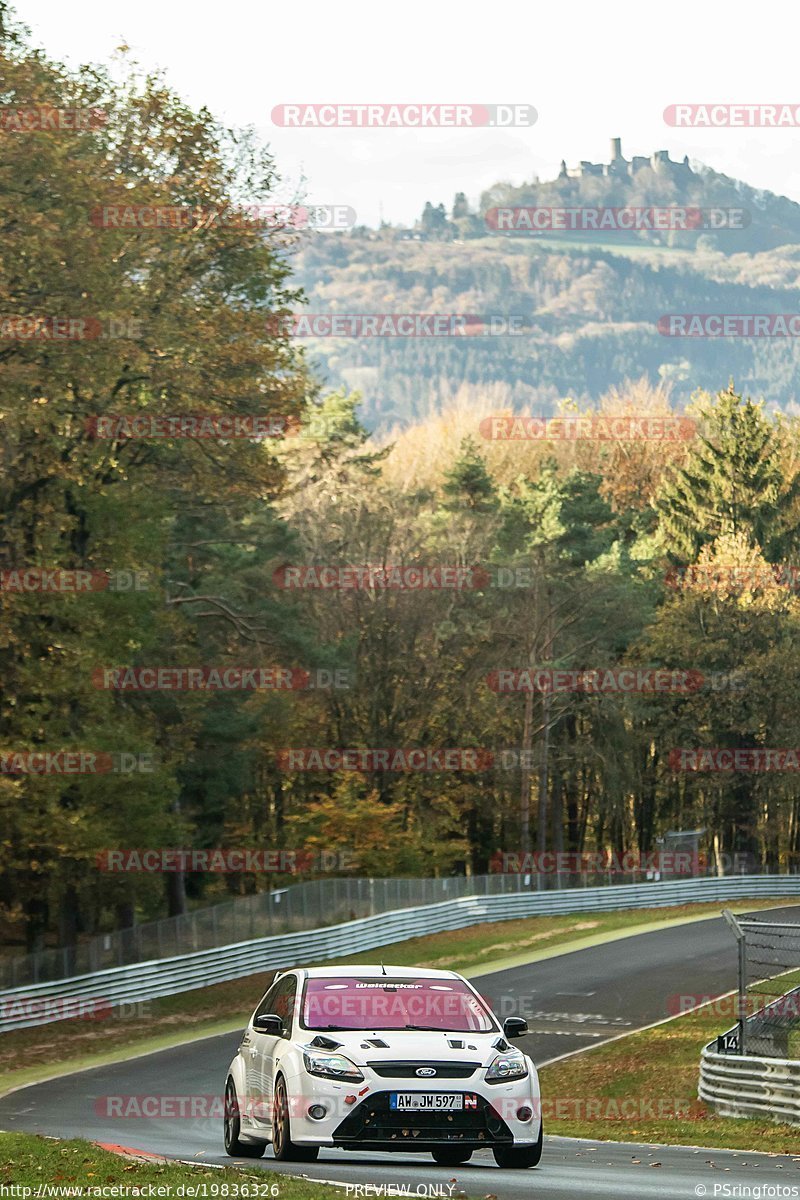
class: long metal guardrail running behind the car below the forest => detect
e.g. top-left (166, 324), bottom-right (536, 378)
top-left (0, 875), bottom-right (800, 1032)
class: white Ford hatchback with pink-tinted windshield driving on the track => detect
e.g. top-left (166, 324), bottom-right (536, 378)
top-left (224, 966), bottom-right (542, 1168)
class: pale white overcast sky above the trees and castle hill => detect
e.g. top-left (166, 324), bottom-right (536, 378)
top-left (17, 0), bottom-right (800, 224)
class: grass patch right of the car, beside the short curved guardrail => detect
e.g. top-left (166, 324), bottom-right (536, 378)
top-left (540, 1003), bottom-right (800, 1154)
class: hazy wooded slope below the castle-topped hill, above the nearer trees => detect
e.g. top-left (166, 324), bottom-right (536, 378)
top-left (296, 230), bottom-right (800, 431)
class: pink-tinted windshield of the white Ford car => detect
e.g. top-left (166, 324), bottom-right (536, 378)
top-left (302, 976), bottom-right (498, 1033)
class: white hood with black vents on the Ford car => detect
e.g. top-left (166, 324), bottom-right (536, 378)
top-left (299, 1030), bottom-right (507, 1067)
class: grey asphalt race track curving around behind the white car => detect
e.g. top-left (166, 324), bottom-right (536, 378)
top-left (0, 906), bottom-right (800, 1200)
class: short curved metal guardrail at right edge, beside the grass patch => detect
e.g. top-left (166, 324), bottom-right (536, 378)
top-left (697, 1040), bottom-right (800, 1124)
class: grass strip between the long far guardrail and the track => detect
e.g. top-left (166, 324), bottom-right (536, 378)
top-left (0, 896), bottom-right (796, 1094)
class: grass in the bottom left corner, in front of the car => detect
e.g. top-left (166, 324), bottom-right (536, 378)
top-left (0, 1133), bottom-right (328, 1200)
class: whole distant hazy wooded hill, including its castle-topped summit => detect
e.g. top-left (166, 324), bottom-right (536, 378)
top-left (295, 142), bottom-right (800, 431)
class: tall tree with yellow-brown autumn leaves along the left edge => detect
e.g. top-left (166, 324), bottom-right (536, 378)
top-left (0, 9), bottom-right (307, 948)
